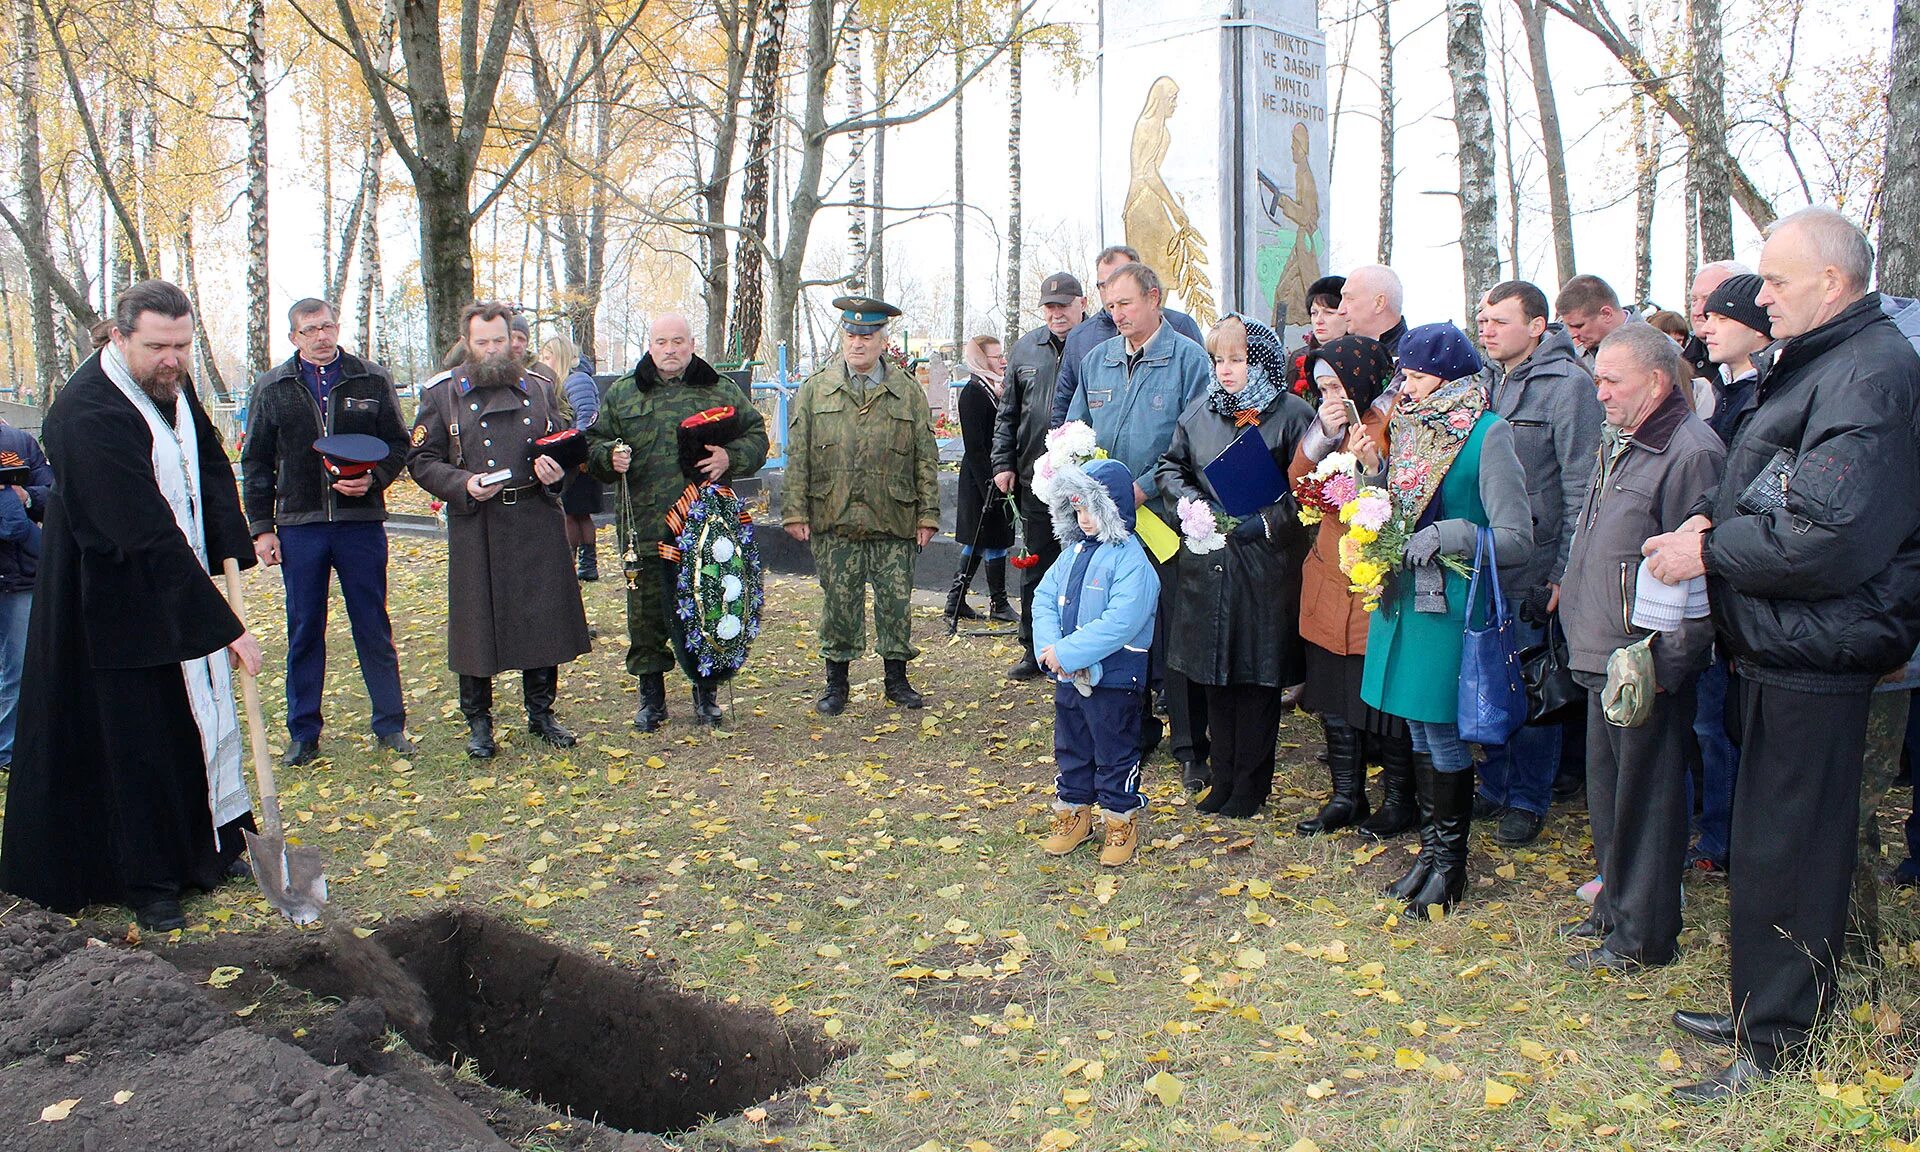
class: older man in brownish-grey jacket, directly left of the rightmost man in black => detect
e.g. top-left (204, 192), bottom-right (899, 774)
top-left (1561, 324), bottom-right (1726, 972)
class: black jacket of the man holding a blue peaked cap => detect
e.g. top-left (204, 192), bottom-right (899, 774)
top-left (240, 351), bottom-right (407, 536)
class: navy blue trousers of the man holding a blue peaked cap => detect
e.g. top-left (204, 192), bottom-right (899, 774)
top-left (278, 520), bottom-right (407, 741)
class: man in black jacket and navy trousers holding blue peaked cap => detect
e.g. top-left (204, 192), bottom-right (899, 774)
top-left (240, 300), bottom-right (413, 764)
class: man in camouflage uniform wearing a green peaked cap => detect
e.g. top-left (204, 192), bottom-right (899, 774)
top-left (781, 296), bottom-right (941, 716)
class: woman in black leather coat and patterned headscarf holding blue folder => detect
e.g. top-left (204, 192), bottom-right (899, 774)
top-left (1156, 315), bottom-right (1313, 818)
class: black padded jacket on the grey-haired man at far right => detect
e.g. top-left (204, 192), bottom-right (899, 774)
top-left (1693, 294), bottom-right (1920, 693)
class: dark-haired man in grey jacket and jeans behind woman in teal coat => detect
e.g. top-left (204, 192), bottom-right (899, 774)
top-left (1475, 280), bottom-right (1605, 845)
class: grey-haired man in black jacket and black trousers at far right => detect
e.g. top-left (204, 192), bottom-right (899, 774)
top-left (1635, 207), bottom-right (1920, 1098)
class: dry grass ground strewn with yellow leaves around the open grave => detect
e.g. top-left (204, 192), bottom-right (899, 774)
top-left (3, 514), bottom-right (1920, 1152)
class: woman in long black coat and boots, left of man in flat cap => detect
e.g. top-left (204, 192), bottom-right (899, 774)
top-left (947, 336), bottom-right (1020, 624)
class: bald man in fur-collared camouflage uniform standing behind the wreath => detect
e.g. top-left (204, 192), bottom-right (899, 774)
top-left (588, 313), bottom-right (766, 732)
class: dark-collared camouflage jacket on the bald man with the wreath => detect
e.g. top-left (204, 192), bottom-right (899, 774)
top-left (588, 355), bottom-right (766, 543)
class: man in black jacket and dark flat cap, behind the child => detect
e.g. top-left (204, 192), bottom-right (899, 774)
top-left (989, 273), bottom-right (1087, 680)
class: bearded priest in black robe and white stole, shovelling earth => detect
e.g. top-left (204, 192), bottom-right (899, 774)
top-left (0, 280), bottom-right (259, 931)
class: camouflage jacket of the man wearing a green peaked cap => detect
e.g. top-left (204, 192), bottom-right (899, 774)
top-left (780, 359), bottom-right (941, 540)
